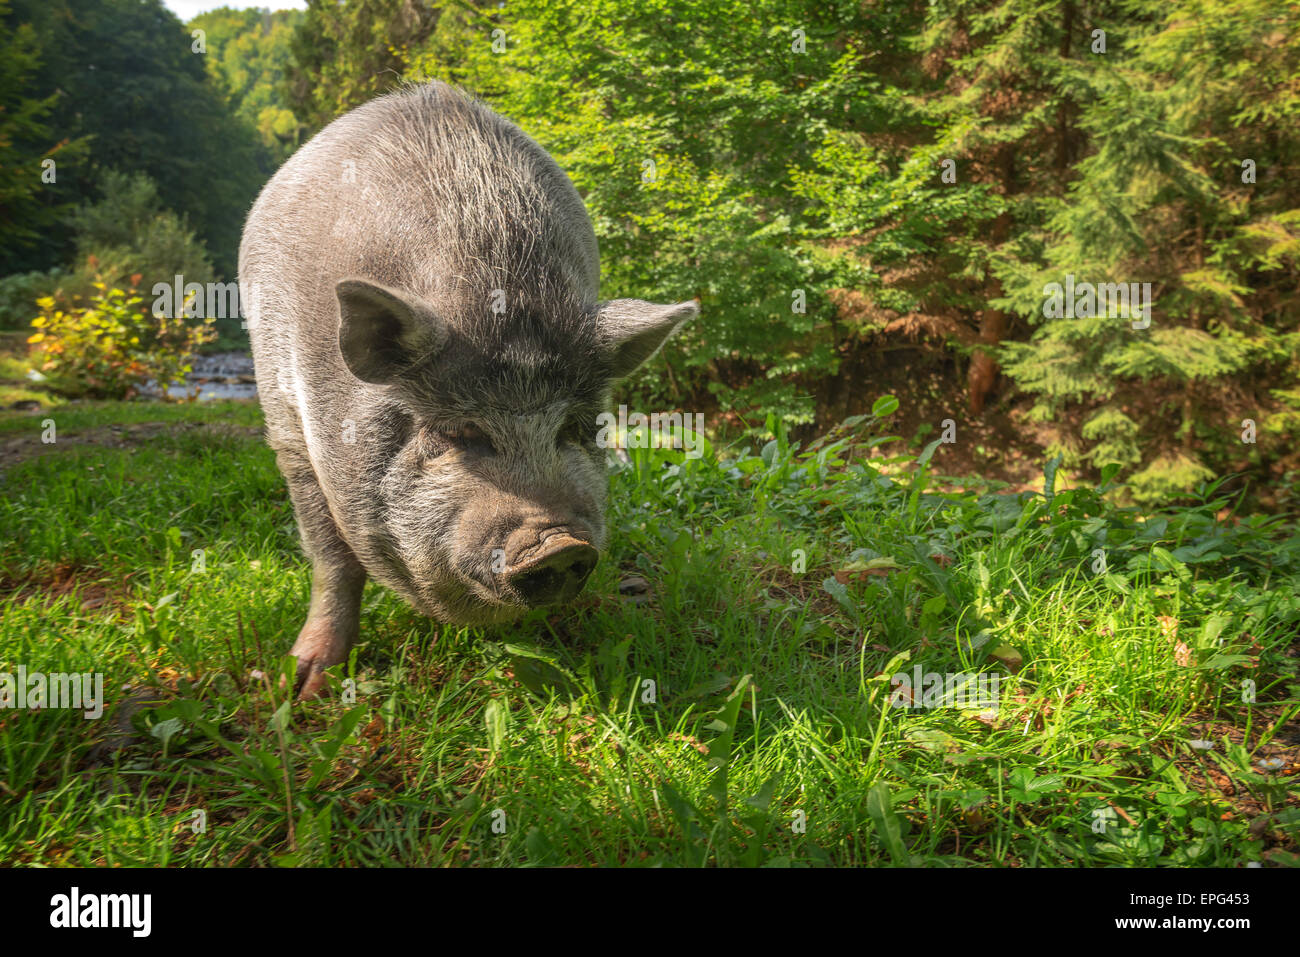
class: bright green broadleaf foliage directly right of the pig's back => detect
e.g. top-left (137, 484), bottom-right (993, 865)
top-left (408, 0), bottom-right (891, 428)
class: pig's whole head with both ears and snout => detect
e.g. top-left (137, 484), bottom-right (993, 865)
top-left (335, 273), bottom-right (697, 624)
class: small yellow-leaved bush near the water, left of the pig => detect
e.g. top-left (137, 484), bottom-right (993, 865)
top-left (27, 274), bottom-right (213, 398)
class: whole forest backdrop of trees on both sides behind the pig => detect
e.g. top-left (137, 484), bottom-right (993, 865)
top-left (0, 0), bottom-right (1300, 508)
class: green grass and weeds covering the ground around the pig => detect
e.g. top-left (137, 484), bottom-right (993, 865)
top-left (0, 403), bottom-right (1300, 866)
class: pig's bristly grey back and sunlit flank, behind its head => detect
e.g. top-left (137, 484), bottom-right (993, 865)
top-left (239, 83), bottom-right (599, 459)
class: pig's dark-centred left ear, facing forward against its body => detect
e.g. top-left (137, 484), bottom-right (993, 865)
top-left (334, 280), bottom-right (447, 385)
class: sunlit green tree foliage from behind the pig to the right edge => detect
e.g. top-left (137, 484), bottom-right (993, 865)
top-left (403, 0), bottom-right (1300, 488)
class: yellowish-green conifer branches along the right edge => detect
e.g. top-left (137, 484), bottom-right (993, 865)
top-left (995, 0), bottom-right (1300, 502)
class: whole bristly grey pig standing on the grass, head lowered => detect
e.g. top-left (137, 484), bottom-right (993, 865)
top-left (239, 82), bottom-right (697, 698)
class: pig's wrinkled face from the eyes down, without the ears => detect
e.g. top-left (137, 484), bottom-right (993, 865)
top-left (381, 387), bottom-right (607, 624)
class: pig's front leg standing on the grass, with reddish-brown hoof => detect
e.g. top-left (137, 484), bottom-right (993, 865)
top-left (278, 451), bottom-right (365, 698)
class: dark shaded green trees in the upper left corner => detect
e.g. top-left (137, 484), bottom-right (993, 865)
top-left (0, 0), bottom-right (263, 276)
